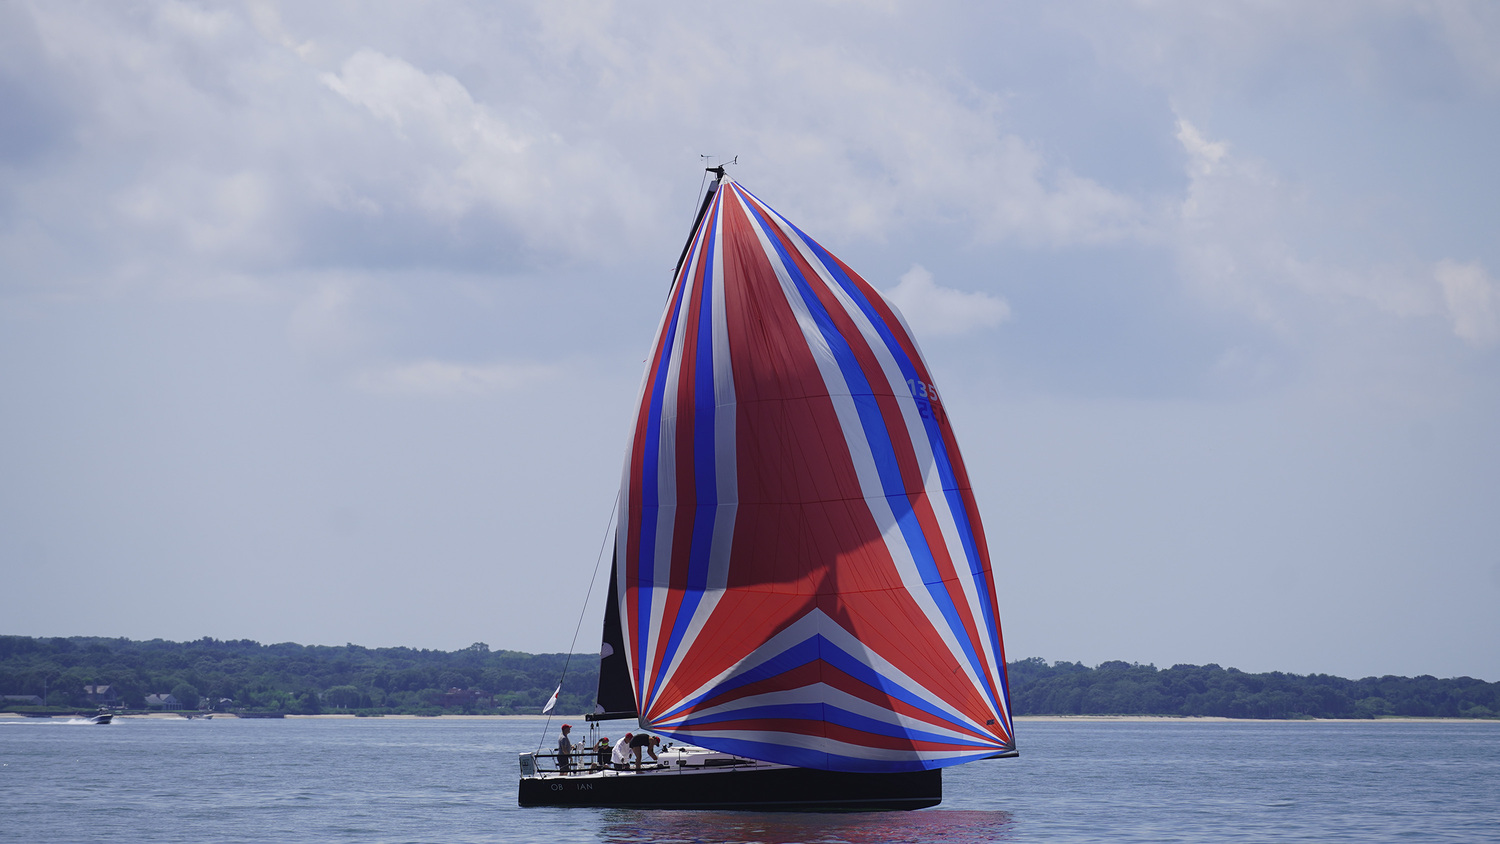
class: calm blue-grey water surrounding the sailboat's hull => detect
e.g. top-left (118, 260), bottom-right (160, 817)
top-left (0, 718), bottom-right (1500, 844)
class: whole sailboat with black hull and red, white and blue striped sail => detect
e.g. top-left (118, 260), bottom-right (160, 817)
top-left (519, 166), bottom-right (1017, 811)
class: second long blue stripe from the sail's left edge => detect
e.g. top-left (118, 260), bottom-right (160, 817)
top-left (651, 202), bottom-right (719, 696)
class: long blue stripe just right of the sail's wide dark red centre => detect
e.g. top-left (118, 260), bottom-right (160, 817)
top-left (747, 204), bottom-right (998, 719)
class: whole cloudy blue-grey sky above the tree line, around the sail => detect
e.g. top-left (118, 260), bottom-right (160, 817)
top-left (0, 0), bottom-right (1500, 681)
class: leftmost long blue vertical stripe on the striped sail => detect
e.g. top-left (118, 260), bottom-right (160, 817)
top-left (626, 224), bottom-right (692, 709)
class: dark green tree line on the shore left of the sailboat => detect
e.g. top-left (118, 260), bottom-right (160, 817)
top-left (0, 636), bottom-right (599, 715)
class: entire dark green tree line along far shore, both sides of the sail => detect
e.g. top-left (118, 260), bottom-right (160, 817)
top-left (0, 636), bottom-right (1500, 718)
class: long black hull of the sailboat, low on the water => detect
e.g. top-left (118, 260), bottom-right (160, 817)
top-left (519, 768), bottom-right (942, 811)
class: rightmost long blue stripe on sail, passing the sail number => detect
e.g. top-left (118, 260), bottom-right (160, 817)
top-left (786, 222), bottom-right (1004, 712)
